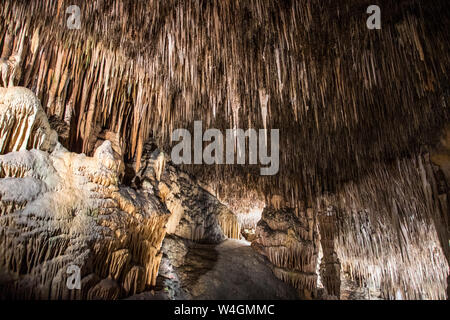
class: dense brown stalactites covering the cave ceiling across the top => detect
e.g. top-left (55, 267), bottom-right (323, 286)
top-left (0, 0), bottom-right (450, 206)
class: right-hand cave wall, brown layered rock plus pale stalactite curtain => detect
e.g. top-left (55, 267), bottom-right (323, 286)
top-left (252, 153), bottom-right (449, 300)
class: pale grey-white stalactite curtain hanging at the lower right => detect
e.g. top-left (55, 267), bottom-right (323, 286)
top-left (319, 155), bottom-right (449, 299)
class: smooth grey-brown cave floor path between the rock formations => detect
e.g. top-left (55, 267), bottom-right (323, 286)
top-left (128, 239), bottom-right (298, 300)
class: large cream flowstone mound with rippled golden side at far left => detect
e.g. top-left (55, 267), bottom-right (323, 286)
top-left (0, 88), bottom-right (170, 299)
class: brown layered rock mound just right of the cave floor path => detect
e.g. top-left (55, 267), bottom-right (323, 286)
top-left (252, 201), bottom-right (319, 299)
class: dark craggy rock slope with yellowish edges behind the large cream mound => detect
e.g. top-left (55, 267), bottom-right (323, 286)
top-left (137, 149), bottom-right (240, 243)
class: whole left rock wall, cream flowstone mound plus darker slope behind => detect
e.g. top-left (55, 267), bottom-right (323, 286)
top-left (0, 88), bottom-right (248, 299)
